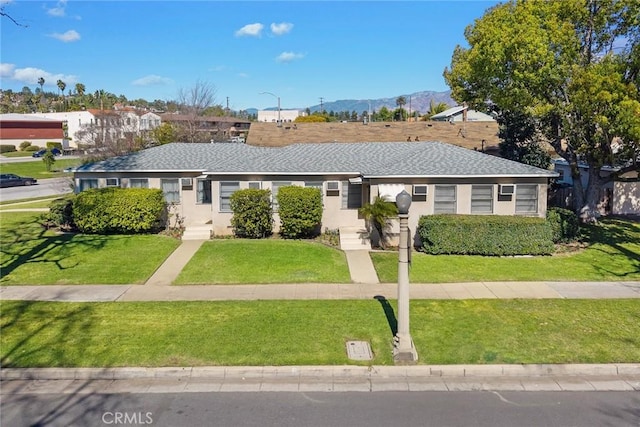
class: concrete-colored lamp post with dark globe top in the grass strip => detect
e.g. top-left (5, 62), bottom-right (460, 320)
top-left (393, 190), bottom-right (418, 364)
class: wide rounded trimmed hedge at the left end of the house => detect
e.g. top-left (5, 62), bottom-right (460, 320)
top-left (73, 187), bottom-right (167, 234)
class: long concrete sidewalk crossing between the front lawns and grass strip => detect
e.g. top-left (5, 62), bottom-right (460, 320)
top-left (0, 282), bottom-right (640, 302)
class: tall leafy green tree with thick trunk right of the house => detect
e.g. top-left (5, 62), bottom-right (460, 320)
top-left (444, 0), bottom-right (640, 222)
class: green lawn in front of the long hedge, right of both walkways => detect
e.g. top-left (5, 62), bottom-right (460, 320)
top-left (371, 219), bottom-right (640, 283)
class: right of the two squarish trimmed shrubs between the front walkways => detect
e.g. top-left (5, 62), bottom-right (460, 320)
top-left (278, 185), bottom-right (322, 239)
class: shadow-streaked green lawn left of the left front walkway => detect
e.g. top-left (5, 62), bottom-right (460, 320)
top-left (0, 212), bottom-right (179, 285)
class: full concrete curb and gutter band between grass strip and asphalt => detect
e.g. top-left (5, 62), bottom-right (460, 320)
top-left (0, 363), bottom-right (640, 394)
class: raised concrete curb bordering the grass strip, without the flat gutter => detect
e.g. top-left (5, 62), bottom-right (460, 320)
top-left (0, 363), bottom-right (640, 381)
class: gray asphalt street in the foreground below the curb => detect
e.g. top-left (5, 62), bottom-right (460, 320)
top-left (0, 391), bottom-right (640, 427)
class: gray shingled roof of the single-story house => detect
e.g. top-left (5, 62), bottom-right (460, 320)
top-left (76, 142), bottom-right (556, 177)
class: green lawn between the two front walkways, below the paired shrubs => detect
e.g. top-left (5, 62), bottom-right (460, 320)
top-left (176, 239), bottom-right (351, 284)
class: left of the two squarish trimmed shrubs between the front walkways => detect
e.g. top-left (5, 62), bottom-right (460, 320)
top-left (230, 188), bottom-right (273, 239)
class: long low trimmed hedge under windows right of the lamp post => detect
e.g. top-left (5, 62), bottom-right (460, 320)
top-left (418, 215), bottom-right (554, 256)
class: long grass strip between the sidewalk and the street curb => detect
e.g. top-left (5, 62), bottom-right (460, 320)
top-left (0, 300), bottom-right (640, 367)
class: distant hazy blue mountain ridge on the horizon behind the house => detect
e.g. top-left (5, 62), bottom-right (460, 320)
top-left (246, 90), bottom-right (458, 114)
